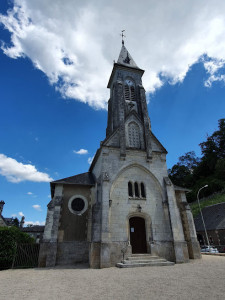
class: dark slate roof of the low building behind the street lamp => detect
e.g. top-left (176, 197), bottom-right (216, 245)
top-left (194, 202), bottom-right (225, 231)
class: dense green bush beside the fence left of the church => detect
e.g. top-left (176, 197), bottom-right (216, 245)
top-left (0, 226), bottom-right (34, 270)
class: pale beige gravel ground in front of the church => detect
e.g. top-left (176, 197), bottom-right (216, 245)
top-left (0, 256), bottom-right (225, 300)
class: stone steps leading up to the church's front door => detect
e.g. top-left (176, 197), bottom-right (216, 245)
top-left (116, 254), bottom-right (174, 268)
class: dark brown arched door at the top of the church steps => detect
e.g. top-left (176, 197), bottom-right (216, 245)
top-left (129, 217), bottom-right (147, 253)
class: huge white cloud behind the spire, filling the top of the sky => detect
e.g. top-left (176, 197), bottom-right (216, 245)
top-left (0, 0), bottom-right (225, 108)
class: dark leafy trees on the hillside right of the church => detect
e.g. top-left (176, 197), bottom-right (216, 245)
top-left (168, 119), bottom-right (225, 202)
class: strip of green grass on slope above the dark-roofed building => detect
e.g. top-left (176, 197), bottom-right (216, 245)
top-left (190, 191), bottom-right (225, 218)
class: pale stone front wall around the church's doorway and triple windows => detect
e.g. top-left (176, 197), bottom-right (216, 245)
top-left (90, 147), bottom-right (177, 267)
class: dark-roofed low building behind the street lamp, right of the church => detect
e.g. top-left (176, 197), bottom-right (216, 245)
top-left (194, 202), bottom-right (225, 252)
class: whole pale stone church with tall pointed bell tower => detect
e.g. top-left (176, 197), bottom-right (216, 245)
top-left (39, 42), bottom-right (201, 268)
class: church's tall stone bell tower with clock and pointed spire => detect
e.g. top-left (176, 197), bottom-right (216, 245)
top-left (106, 41), bottom-right (152, 160)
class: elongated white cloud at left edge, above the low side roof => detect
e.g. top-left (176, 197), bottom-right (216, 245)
top-left (0, 154), bottom-right (53, 183)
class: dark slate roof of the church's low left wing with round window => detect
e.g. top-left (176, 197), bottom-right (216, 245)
top-left (51, 172), bottom-right (95, 185)
